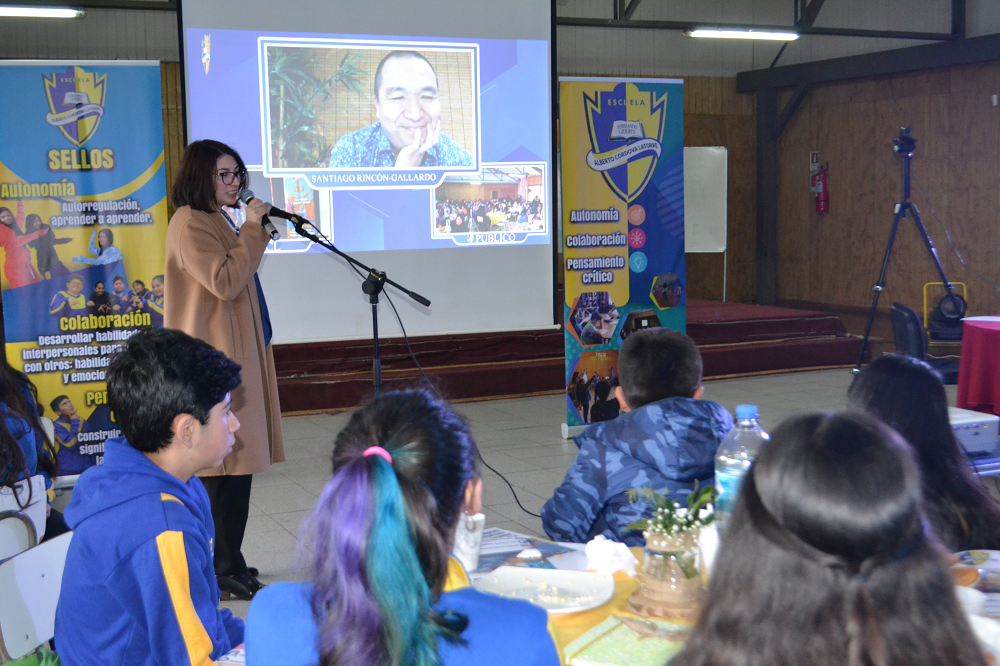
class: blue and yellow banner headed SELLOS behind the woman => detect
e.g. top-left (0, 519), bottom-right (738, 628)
top-left (0, 60), bottom-right (167, 475)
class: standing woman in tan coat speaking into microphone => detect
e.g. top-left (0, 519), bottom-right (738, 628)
top-left (164, 140), bottom-right (285, 599)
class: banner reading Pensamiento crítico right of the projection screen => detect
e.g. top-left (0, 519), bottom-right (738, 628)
top-left (559, 77), bottom-right (687, 426)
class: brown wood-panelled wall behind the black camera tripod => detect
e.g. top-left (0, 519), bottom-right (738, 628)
top-left (778, 63), bottom-right (1000, 314)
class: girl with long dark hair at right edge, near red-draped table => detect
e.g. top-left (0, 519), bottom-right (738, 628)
top-left (847, 356), bottom-right (1000, 551)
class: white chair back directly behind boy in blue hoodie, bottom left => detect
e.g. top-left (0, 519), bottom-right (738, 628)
top-left (0, 532), bottom-right (73, 661)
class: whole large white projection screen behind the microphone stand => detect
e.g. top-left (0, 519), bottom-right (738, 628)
top-left (180, 0), bottom-right (556, 343)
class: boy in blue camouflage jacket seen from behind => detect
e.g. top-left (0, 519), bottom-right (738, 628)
top-left (542, 328), bottom-right (733, 546)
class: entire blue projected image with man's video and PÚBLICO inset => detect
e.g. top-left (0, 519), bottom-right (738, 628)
top-left (185, 28), bottom-right (552, 253)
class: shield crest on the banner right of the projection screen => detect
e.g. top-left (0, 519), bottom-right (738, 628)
top-left (583, 83), bottom-right (667, 203)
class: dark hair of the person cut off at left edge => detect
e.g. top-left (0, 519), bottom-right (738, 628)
top-left (0, 354), bottom-right (59, 507)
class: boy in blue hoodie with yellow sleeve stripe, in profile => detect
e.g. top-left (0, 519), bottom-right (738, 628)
top-left (55, 329), bottom-right (243, 666)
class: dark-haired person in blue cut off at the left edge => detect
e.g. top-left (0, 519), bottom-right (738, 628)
top-left (0, 354), bottom-right (69, 540)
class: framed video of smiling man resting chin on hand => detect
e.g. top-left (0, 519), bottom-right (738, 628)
top-left (262, 41), bottom-right (479, 175)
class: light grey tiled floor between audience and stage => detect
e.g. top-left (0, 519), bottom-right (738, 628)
top-left (52, 370), bottom-right (955, 617)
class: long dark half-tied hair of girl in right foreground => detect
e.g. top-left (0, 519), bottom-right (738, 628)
top-left (670, 413), bottom-right (984, 666)
